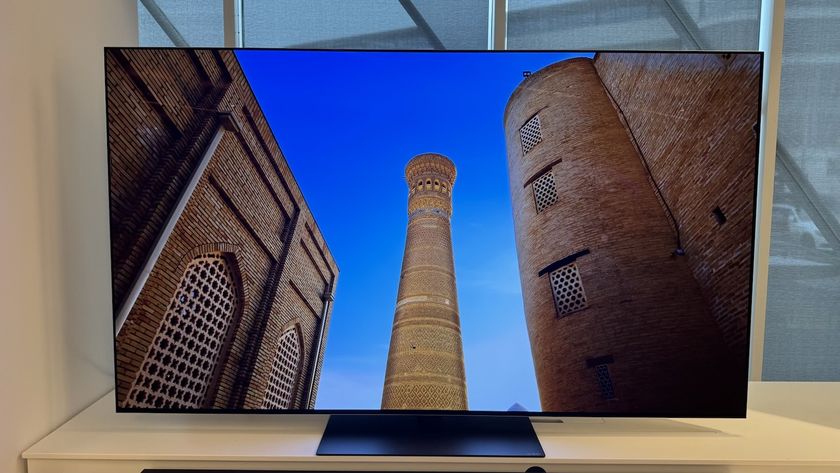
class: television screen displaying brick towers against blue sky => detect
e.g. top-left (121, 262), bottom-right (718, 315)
top-left (105, 48), bottom-right (763, 417)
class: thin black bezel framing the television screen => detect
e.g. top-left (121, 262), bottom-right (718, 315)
top-left (103, 46), bottom-right (766, 419)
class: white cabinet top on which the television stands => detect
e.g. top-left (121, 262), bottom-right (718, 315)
top-left (23, 382), bottom-right (840, 473)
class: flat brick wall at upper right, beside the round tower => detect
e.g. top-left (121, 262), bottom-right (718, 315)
top-left (595, 53), bottom-right (761, 359)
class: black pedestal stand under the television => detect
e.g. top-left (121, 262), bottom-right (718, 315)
top-left (316, 414), bottom-right (545, 458)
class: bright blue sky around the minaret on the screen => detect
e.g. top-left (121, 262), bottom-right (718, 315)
top-left (236, 50), bottom-right (592, 410)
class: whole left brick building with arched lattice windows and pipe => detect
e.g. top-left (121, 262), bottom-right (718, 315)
top-left (105, 49), bottom-right (338, 409)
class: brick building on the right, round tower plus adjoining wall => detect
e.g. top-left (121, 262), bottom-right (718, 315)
top-left (505, 53), bottom-right (761, 416)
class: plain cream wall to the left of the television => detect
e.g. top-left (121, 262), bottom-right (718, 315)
top-left (0, 0), bottom-right (137, 473)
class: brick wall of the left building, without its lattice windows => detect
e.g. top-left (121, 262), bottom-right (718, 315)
top-left (106, 49), bottom-right (338, 409)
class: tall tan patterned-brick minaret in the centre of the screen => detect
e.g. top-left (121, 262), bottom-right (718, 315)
top-left (382, 153), bottom-right (467, 410)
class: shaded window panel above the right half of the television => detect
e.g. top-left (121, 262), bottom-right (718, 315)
top-left (507, 0), bottom-right (761, 50)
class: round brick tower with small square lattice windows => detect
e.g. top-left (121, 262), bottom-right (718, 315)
top-left (505, 59), bottom-right (745, 415)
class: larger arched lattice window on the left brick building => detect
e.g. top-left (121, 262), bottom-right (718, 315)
top-left (126, 253), bottom-right (237, 408)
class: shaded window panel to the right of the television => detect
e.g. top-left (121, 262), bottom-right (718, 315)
top-left (762, 0), bottom-right (840, 381)
